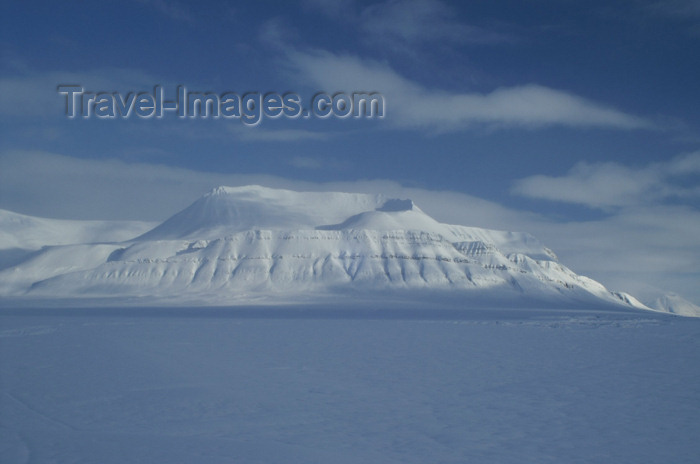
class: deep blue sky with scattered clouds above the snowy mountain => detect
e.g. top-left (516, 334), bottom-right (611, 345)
top-left (0, 0), bottom-right (700, 303)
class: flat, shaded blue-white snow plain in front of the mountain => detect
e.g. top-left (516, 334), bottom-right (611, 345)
top-left (0, 308), bottom-right (700, 464)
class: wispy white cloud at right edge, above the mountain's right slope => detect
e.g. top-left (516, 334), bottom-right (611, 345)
top-left (512, 152), bottom-right (700, 209)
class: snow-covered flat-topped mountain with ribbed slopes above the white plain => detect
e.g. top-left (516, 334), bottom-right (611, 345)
top-left (0, 186), bottom-right (684, 309)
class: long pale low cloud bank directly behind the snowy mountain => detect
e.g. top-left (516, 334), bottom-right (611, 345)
top-left (0, 152), bottom-right (700, 303)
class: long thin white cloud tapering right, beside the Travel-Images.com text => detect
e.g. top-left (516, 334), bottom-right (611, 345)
top-left (286, 48), bottom-right (652, 131)
